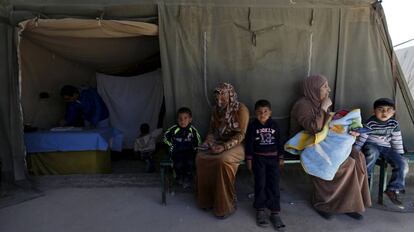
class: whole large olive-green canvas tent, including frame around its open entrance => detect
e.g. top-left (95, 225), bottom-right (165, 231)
top-left (0, 0), bottom-right (414, 188)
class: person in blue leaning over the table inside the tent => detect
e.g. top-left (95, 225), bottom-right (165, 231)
top-left (60, 85), bottom-right (109, 128)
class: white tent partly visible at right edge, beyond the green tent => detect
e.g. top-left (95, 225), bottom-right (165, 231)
top-left (395, 46), bottom-right (414, 97)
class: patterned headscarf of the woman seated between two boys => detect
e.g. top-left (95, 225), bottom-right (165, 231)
top-left (214, 83), bottom-right (240, 135)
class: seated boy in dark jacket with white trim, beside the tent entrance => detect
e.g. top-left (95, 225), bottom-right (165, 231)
top-left (164, 107), bottom-right (201, 188)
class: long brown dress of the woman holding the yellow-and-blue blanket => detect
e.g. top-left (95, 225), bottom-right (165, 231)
top-left (290, 98), bottom-right (371, 213)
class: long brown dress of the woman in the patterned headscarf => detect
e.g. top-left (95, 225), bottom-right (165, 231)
top-left (196, 104), bottom-right (249, 216)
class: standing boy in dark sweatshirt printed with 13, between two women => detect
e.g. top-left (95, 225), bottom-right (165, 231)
top-left (245, 100), bottom-right (285, 229)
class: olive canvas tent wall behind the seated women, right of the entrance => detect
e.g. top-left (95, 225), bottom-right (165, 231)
top-left (159, 1), bottom-right (414, 150)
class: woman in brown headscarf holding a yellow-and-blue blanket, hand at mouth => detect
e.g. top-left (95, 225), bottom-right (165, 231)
top-left (290, 75), bottom-right (371, 220)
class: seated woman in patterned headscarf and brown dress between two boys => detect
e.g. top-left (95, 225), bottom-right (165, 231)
top-left (196, 83), bottom-right (249, 218)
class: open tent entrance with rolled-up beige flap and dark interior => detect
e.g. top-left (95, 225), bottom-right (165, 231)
top-left (18, 18), bottom-right (163, 174)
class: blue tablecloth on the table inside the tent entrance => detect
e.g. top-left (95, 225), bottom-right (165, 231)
top-left (24, 128), bottom-right (123, 152)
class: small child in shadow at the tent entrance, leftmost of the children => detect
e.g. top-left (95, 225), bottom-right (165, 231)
top-left (134, 123), bottom-right (162, 172)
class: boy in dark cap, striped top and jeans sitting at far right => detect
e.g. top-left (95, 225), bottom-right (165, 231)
top-left (354, 98), bottom-right (408, 208)
